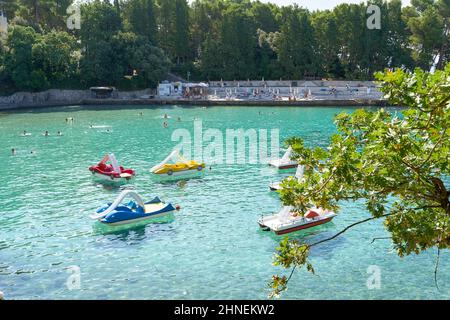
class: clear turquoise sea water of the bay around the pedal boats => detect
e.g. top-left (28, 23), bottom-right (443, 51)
top-left (0, 107), bottom-right (450, 299)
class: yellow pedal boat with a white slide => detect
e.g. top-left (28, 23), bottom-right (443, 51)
top-left (150, 150), bottom-right (205, 179)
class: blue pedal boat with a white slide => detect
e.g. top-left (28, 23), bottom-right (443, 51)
top-left (90, 190), bottom-right (179, 226)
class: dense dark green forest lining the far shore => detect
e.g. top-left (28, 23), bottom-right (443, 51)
top-left (0, 0), bottom-right (450, 94)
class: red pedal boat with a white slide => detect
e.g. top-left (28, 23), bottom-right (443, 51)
top-left (89, 153), bottom-right (136, 183)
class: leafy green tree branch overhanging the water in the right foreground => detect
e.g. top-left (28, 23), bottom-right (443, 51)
top-left (270, 64), bottom-right (450, 297)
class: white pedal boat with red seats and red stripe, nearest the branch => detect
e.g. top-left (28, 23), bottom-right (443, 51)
top-left (258, 206), bottom-right (336, 235)
